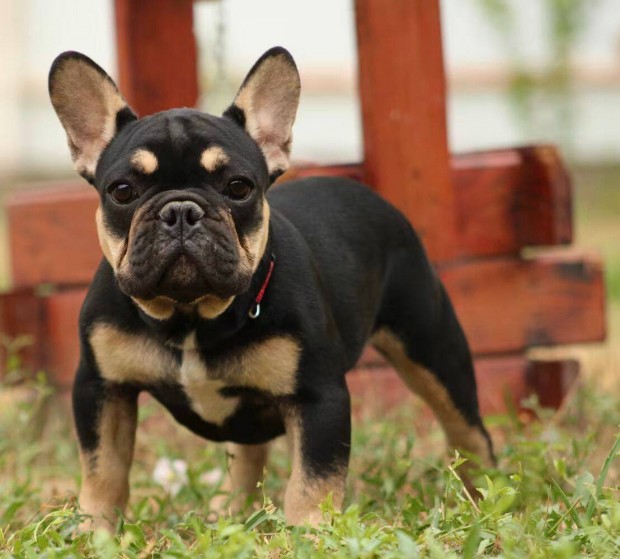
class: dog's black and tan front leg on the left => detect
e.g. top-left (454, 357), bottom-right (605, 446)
top-left (73, 365), bottom-right (137, 530)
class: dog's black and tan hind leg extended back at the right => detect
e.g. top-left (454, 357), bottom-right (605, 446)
top-left (371, 264), bottom-right (495, 466)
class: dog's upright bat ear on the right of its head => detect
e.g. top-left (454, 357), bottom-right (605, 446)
top-left (224, 47), bottom-right (301, 181)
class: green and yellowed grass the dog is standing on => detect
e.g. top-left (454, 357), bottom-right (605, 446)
top-left (0, 164), bottom-right (620, 559)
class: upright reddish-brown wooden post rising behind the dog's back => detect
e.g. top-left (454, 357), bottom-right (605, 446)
top-left (355, 0), bottom-right (457, 260)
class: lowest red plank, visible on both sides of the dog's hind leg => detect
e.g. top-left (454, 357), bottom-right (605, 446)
top-left (347, 355), bottom-right (579, 419)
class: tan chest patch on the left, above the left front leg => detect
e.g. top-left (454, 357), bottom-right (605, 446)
top-left (90, 324), bottom-right (179, 383)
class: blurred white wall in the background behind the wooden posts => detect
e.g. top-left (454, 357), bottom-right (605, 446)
top-left (0, 0), bottom-right (620, 181)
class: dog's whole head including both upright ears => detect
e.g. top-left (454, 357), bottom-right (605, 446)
top-left (49, 47), bottom-right (300, 319)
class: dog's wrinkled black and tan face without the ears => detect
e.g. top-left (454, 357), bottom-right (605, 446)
top-left (95, 109), bottom-right (269, 320)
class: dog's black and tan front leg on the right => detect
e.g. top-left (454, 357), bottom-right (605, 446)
top-left (284, 381), bottom-right (351, 526)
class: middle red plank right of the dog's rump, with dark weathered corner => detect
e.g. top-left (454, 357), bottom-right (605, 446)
top-left (439, 253), bottom-right (605, 355)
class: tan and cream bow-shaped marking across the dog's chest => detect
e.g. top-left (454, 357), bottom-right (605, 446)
top-left (89, 324), bottom-right (300, 425)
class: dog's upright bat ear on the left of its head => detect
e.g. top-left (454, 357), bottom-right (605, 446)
top-left (49, 51), bottom-right (138, 183)
